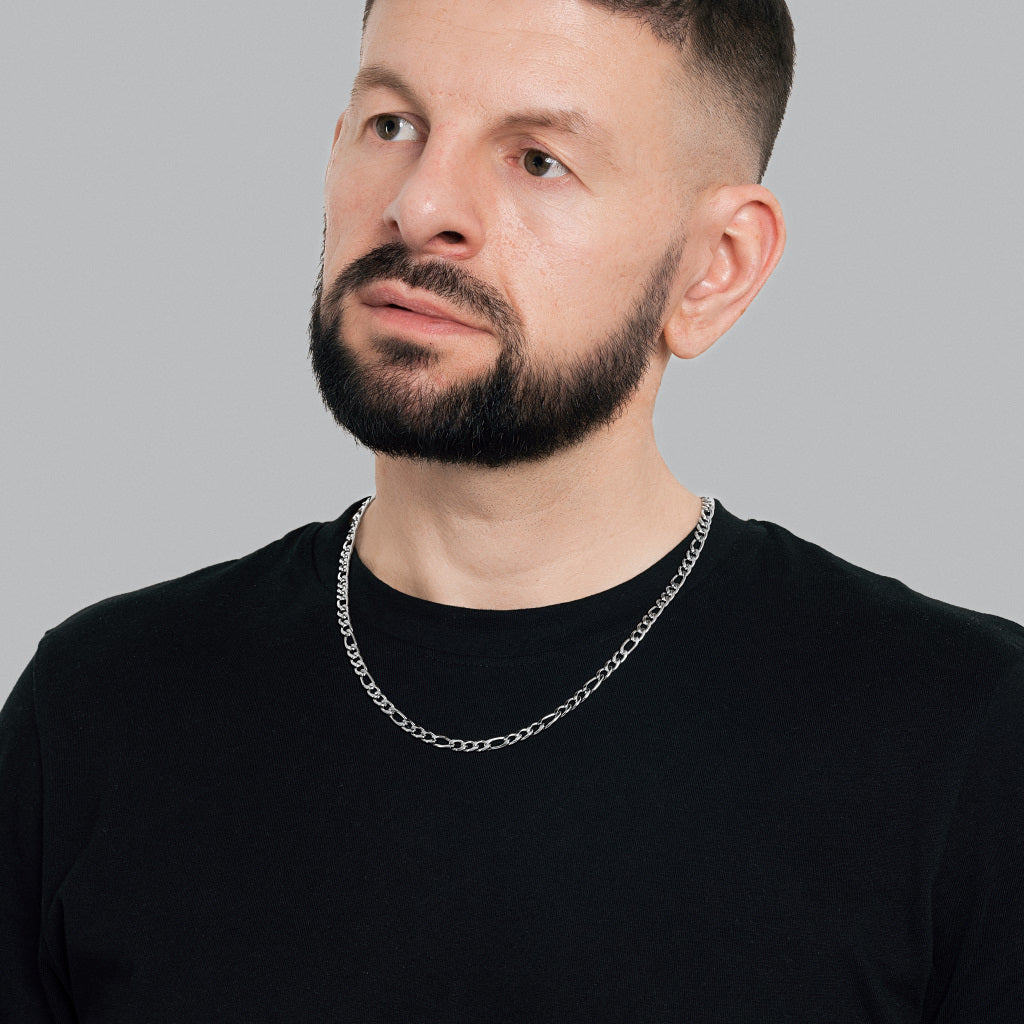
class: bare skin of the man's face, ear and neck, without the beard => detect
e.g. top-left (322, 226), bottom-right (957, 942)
top-left (324, 0), bottom-right (784, 608)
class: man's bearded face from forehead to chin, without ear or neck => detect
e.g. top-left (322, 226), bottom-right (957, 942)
top-left (310, 0), bottom-right (704, 465)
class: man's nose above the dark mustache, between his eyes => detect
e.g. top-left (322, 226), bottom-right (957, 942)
top-left (384, 134), bottom-right (483, 259)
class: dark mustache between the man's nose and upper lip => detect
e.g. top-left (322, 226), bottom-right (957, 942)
top-left (324, 242), bottom-right (523, 337)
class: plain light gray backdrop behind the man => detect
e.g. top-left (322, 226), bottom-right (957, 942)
top-left (0, 0), bottom-right (1024, 697)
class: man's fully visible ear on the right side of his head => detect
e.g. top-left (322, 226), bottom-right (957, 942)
top-left (665, 184), bottom-right (785, 359)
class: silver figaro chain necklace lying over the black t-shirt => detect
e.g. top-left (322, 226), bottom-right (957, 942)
top-left (338, 497), bottom-right (715, 753)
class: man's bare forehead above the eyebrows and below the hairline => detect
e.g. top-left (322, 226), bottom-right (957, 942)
top-left (360, 0), bottom-right (683, 142)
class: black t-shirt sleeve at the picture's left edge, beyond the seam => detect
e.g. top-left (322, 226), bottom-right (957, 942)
top-left (0, 663), bottom-right (74, 1024)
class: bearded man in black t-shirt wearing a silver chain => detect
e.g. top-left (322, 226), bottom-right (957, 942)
top-left (0, 0), bottom-right (1024, 1022)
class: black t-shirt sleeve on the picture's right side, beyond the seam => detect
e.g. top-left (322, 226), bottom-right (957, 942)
top-left (925, 660), bottom-right (1024, 1024)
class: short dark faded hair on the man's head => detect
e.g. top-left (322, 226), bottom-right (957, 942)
top-left (362, 0), bottom-right (797, 181)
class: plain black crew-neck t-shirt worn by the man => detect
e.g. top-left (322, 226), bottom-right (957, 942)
top-left (6, 505), bottom-right (1024, 1024)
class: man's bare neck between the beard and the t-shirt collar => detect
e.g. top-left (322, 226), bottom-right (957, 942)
top-left (356, 420), bottom-right (700, 609)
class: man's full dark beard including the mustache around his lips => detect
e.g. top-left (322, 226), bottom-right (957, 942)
top-left (309, 242), bottom-right (682, 468)
